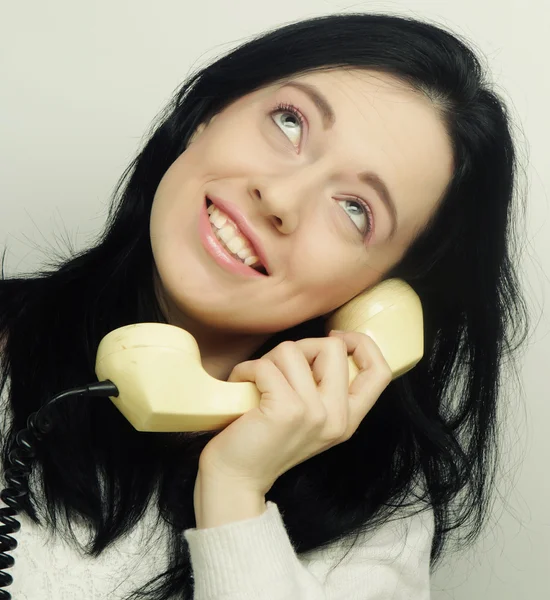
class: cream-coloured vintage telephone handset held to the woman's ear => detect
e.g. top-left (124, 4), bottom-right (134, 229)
top-left (96, 279), bottom-right (424, 432)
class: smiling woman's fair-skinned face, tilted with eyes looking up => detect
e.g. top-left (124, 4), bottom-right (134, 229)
top-left (150, 70), bottom-right (453, 334)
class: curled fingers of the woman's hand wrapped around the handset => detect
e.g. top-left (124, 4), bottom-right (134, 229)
top-left (228, 331), bottom-right (392, 437)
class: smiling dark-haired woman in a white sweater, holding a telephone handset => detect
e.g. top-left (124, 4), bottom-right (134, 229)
top-left (0, 14), bottom-right (525, 600)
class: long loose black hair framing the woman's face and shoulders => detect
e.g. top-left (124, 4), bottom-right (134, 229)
top-left (0, 14), bottom-right (527, 600)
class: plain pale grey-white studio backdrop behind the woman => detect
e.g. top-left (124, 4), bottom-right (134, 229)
top-left (0, 0), bottom-right (550, 600)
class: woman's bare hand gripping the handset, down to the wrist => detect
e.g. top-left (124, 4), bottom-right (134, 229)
top-left (199, 331), bottom-right (392, 495)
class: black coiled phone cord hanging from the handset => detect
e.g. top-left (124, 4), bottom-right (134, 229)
top-left (0, 380), bottom-right (118, 600)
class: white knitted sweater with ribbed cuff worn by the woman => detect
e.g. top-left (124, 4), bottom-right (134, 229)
top-left (0, 384), bottom-right (434, 600)
